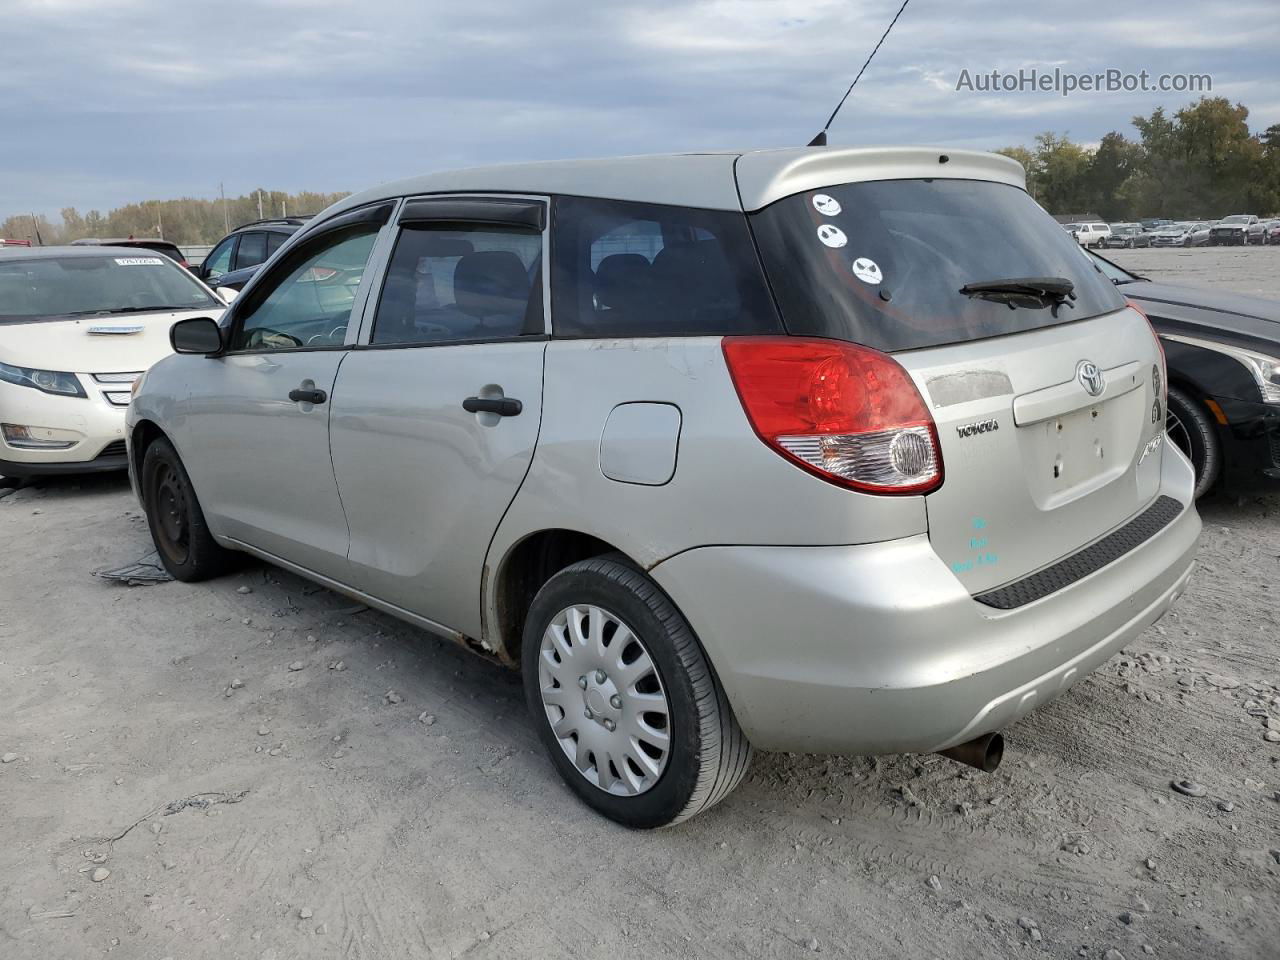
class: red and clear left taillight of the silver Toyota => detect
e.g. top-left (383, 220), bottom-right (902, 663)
top-left (723, 337), bottom-right (942, 494)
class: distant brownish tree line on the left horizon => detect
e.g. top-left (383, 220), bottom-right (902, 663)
top-left (0, 189), bottom-right (347, 244)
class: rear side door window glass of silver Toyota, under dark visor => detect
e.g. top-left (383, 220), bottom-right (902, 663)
top-left (372, 223), bottom-right (544, 344)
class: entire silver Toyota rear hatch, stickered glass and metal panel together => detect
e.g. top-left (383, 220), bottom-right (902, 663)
top-left (751, 170), bottom-right (1164, 594)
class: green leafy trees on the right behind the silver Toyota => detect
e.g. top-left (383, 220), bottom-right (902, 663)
top-left (997, 97), bottom-right (1280, 221)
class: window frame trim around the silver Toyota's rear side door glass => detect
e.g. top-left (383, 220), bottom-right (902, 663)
top-left (349, 192), bottom-right (552, 351)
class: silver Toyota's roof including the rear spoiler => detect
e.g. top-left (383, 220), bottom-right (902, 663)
top-left (315, 147), bottom-right (1027, 223)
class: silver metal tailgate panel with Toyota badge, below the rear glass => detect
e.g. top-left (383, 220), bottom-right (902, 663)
top-left (896, 308), bottom-right (1164, 593)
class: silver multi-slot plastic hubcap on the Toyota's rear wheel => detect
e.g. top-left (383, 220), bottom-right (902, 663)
top-left (538, 604), bottom-right (671, 796)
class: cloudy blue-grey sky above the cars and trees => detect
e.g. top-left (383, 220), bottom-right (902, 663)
top-left (0, 0), bottom-right (1280, 219)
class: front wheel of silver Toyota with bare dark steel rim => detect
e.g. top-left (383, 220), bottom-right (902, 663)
top-left (141, 436), bottom-right (239, 584)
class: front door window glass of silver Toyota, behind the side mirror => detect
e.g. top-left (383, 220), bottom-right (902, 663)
top-left (230, 223), bottom-right (379, 351)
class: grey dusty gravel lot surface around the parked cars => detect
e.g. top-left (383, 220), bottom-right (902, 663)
top-left (0, 250), bottom-right (1280, 960)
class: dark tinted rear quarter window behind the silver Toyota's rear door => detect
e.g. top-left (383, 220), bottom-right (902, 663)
top-left (552, 197), bottom-right (781, 338)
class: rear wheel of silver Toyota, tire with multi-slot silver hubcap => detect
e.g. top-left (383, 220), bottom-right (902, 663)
top-left (521, 556), bottom-right (751, 828)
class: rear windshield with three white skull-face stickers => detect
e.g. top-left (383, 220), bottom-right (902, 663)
top-left (751, 179), bottom-right (1124, 351)
